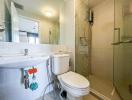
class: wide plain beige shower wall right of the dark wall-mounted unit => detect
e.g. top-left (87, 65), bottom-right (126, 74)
top-left (91, 0), bottom-right (114, 80)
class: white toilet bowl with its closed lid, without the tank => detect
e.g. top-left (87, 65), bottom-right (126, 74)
top-left (58, 71), bottom-right (89, 97)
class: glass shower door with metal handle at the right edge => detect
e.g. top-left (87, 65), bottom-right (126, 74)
top-left (113, 0), bottom-right (132, 100)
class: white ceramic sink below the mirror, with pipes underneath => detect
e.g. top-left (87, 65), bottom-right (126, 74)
top-left (0, 56), bottom-right (49, 69)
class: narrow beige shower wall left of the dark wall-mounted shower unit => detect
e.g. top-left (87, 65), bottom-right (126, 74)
top-left (75, 0), bottom-right (91, 76)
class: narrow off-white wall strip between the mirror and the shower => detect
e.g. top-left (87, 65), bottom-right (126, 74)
top-left (60, 0), bottom-right (76, 70)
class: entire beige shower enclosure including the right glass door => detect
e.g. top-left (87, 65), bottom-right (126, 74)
top-left (75, 0), bottom-right (132, 100)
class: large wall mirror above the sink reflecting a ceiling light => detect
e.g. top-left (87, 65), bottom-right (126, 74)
top-left (0, 0), bottom-right (64, 44)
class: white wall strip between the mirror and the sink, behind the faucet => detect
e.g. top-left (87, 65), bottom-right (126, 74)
top-left (0, 42), bottom-right (68, 55)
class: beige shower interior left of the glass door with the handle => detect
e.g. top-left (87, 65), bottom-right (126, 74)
top-left (75, 0), bottom-right (114, 100)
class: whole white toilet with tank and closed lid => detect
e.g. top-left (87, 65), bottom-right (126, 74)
top-left (52, 54), bottom-right (90, 100)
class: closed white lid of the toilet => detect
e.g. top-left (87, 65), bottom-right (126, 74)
top-left (60, 71), bottom-right (89, 89)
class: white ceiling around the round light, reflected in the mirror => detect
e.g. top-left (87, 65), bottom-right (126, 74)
top-left (13, 0), bottom-right (63, 18)
